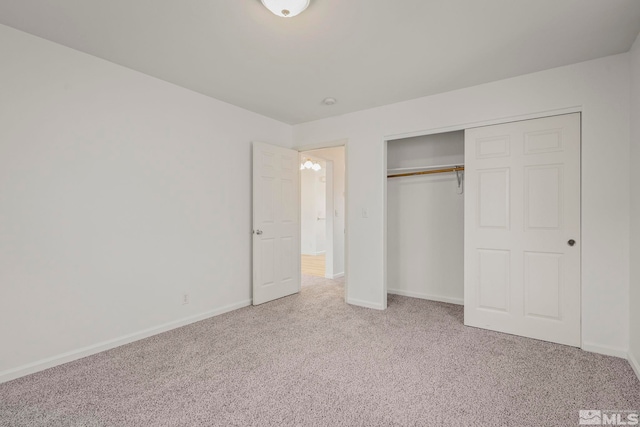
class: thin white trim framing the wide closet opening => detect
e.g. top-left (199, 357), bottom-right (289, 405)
top-left (379, 106), bottom-right (585, 340)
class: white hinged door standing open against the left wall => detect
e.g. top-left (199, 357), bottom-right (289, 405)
top-left (253, 142), bottom-right (300, 305)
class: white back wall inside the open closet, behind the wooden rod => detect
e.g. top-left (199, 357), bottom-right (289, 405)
top-left (387, 131), bottom-right (464, 304)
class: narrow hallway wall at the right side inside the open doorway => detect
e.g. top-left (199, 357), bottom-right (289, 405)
top-left (310, 147), bottom-right (346, 278)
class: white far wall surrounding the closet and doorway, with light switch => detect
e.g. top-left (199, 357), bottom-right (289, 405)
top-left (293, 54), bottom-right (630, 356)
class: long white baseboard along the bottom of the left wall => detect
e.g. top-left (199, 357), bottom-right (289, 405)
top-left (0, 300), bottom-right (251, 384)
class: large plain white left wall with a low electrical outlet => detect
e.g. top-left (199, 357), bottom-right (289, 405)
top-left (0, 26), bottom-right (291, 381)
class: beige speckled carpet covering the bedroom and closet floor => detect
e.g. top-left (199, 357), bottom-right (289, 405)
top-left (0, 278), bottom-right (640, 426)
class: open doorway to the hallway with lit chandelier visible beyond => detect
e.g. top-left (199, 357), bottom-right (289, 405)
top-left (300, 146), bottom-right (346, 287)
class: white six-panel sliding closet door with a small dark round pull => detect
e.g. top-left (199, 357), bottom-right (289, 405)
top-left (464, 113), bottom-right (580, 346)
